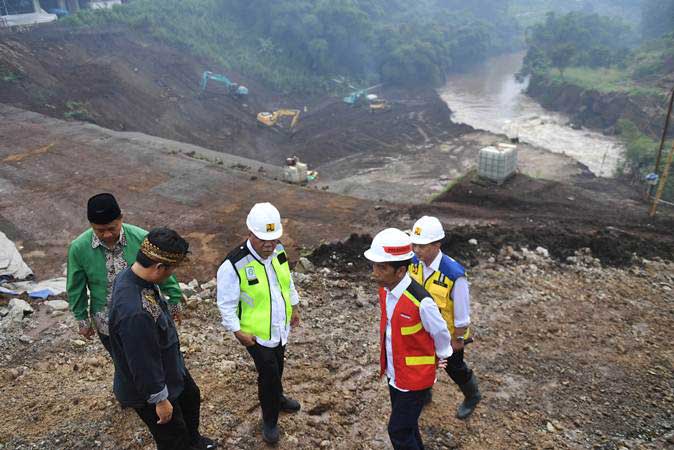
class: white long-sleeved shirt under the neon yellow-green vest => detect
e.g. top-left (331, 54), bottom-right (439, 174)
top-left (216, 241), bottom-right (300, 348)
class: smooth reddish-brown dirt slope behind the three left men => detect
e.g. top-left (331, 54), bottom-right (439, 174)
top-left (0, 105), bottom-right (377, 278)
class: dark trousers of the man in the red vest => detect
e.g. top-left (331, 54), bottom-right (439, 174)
top-left (388, 384), bottom-right (428, 450)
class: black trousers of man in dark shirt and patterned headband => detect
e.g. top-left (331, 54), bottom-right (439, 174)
top-left (135, 372), bottom-right (201, 450)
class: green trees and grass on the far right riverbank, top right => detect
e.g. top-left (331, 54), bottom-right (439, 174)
top-left (520, 0), bottom-right (674, 91)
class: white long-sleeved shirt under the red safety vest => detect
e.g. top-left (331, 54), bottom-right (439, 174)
top-left (385, 274), bottom-right (452, 391)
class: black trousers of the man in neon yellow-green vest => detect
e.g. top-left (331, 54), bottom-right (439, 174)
top-left (246, 344), bottom-right (285, 426)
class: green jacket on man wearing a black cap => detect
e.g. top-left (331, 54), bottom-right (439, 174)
top-left (66, 223), bottom-right (182, 335)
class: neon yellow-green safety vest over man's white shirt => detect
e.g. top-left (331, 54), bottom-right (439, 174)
top-left (234, 250), bottom-right (292, 340)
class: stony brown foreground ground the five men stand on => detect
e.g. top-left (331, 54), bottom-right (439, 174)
top-left (0, 247), bottom-right (674, 450)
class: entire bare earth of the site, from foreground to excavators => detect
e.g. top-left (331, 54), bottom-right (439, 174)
top-left (0, 23), bottom-right (674, 450)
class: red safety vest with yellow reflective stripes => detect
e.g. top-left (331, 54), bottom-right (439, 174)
top-left (379, 280), bottom-right (436, 391)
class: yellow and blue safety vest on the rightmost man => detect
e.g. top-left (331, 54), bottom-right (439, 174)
top-left (409, 254), bottom-right (470, 338)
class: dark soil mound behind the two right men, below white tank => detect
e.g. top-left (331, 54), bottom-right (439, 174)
top-left (311, 173), bottom-right (674, 272)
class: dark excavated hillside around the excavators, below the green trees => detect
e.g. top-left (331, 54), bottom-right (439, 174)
top-left (0, 25), bottom-right (465, 166)
